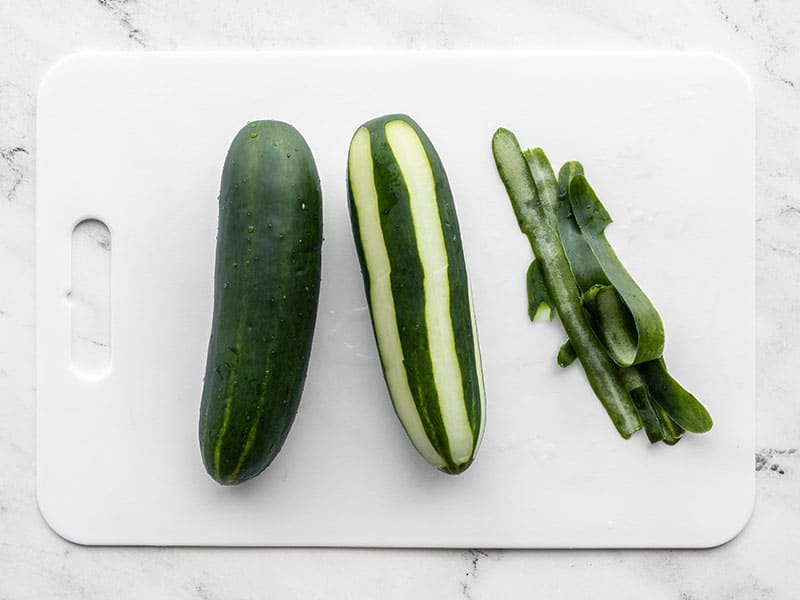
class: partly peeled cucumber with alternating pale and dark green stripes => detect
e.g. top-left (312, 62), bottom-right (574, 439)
top-left (347, 115), bottom-right (486, 474)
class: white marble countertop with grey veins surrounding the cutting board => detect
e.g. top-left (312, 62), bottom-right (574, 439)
top-left (0, 0), bottom-right (800, 600)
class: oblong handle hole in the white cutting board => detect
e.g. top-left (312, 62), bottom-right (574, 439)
top-left (65, 218), bottom-right (111, 379)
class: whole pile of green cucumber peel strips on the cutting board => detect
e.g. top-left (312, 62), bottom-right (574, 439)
top-left (492, 128), bottom-right (713, 445)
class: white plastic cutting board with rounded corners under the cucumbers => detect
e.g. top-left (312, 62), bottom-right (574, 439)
top-left (36, 52), bottom-right (755, 548)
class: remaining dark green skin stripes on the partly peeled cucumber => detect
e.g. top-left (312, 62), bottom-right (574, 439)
top-left (347, 114), bottom-right (485, 474)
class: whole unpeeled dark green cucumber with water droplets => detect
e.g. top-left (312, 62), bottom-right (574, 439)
top-left (200, 121), bottom-right (322, 485)
